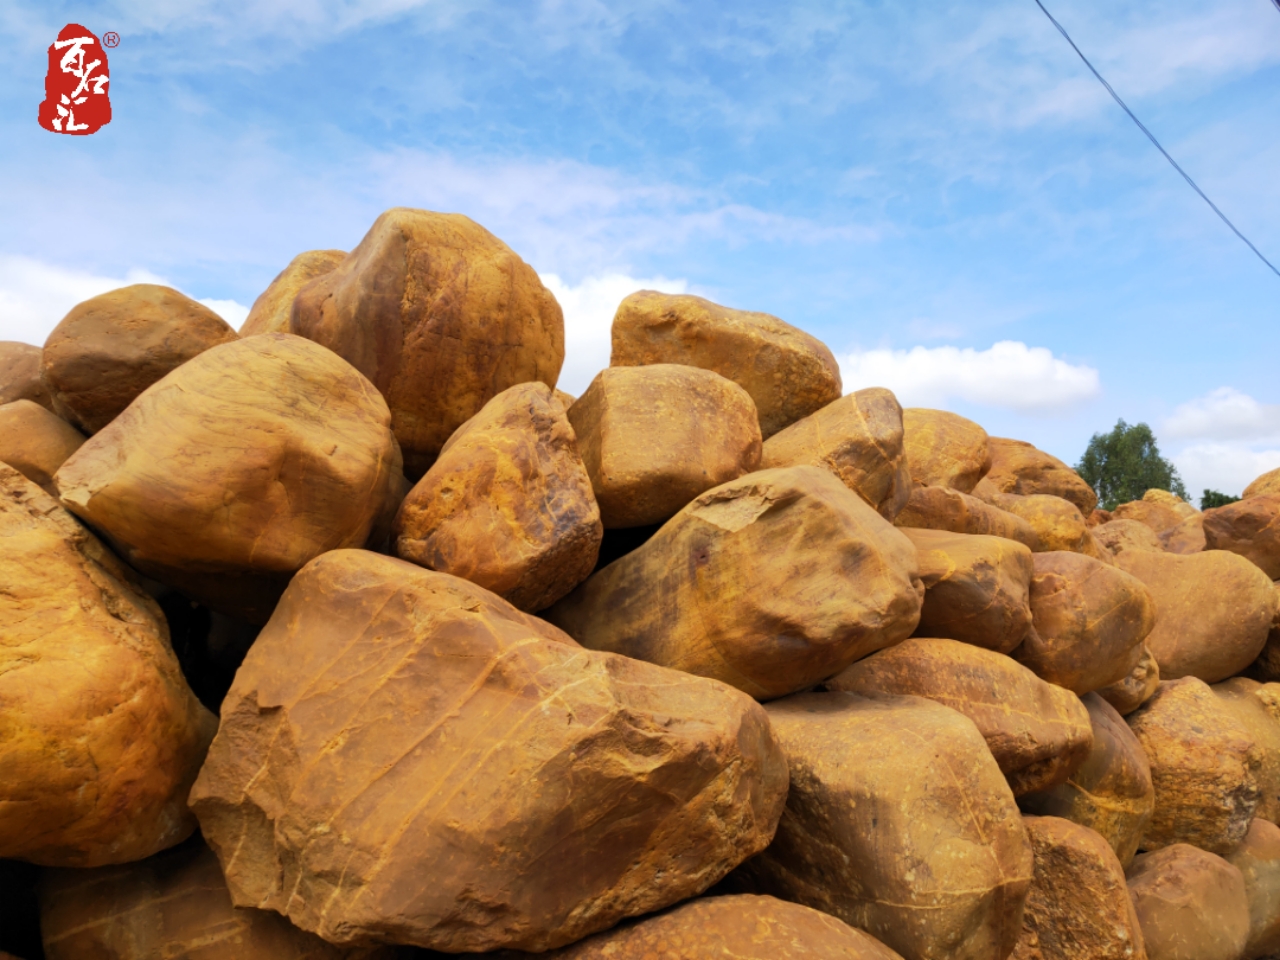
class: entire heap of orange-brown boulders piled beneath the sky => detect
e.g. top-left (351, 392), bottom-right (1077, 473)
top-left (0, 209), bottom-right (1280, 960)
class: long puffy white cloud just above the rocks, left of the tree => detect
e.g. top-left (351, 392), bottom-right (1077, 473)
top-left (840, 340), bottom-right (1101, 413)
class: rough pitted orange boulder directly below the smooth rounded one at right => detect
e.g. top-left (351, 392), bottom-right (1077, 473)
top-left (1128, 677), bottom-right (1262, 856)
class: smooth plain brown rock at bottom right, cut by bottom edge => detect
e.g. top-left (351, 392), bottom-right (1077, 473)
top-left (1129, 844), bottom-right (1249, 960)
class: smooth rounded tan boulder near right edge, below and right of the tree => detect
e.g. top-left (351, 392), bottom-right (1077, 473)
top-left (1116, 550), bottom-right (1276, 684)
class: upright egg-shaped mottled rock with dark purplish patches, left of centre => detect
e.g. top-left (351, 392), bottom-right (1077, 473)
top-left (396, 383), bottom-right (604, 611)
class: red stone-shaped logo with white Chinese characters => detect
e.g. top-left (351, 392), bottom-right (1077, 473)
top-left (40, 23), bottom-right (111, 136)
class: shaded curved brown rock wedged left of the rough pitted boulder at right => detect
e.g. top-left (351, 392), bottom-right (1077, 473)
top-left (1018, 694), bottom-right (1156, 867)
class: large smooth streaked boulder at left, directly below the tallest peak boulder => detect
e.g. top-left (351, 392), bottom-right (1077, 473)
top-left (56, 334), bottom-right (403, 623)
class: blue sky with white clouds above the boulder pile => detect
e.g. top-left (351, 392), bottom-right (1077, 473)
top-left (0, 0), bottom-right (1280, 493)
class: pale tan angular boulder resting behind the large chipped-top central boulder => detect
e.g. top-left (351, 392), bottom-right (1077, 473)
top-left (760, 387), bottom-right (911, 522)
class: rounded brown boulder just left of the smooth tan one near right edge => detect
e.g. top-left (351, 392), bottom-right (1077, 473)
top-left (1012, 552), bottom-right (1158, 694)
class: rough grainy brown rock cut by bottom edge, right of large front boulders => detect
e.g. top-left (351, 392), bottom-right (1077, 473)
top-left (1010, 817), bottom-right (1147, 960)
